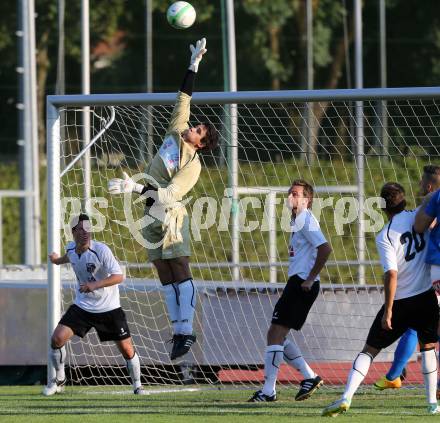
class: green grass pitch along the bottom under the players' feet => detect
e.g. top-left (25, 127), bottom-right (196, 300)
top-left (0, 386), bottom-right (437, 423)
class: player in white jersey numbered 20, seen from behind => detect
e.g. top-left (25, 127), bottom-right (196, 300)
top-left (322, 182), bottom-right (440, 417)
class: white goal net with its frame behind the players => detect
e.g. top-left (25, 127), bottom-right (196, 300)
top-left (48, 89), bottom-right (440, 386)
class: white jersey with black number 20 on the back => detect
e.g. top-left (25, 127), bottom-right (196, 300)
top-left (376, 210), bottom-right (432, 300)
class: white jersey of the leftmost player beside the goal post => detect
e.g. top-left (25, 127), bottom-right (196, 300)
top-left (66, 240), bottom-right (122, 313)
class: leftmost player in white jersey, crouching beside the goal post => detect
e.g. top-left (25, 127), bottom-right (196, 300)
top-left (43, 214), bottom-right (144, 395)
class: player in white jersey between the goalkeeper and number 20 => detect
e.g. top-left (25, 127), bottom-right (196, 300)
top-left (249, 179), bottom-right (331, 402)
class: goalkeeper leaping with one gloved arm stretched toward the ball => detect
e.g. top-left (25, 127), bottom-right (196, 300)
top-left (108, 38), bottom-right (218, 360)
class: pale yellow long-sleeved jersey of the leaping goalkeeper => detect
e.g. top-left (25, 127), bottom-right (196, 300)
top-left (147, 91), bottom-right (201, 206)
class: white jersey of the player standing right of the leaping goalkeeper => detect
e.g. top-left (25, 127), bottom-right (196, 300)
top-left (287, 209), bottom-right (327, 280)
